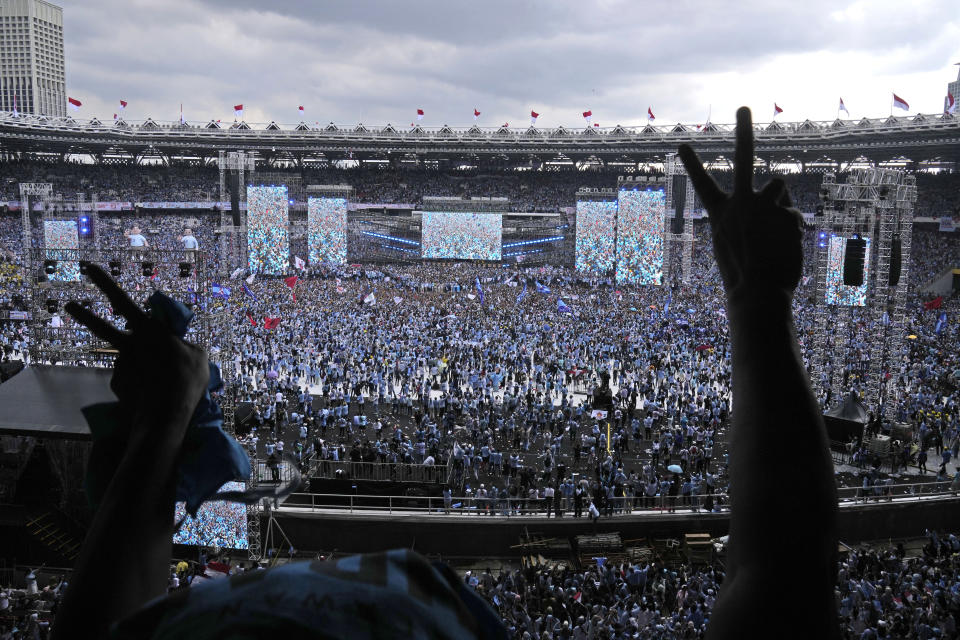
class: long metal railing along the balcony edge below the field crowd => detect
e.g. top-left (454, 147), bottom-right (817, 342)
top-left (283, 482), bottom-right (960, 518)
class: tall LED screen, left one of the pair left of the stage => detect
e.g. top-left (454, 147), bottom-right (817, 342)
top-left (247, 186), bottom-right (290, 275)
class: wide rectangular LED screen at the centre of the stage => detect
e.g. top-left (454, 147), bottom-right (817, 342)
top-left (421, 211), bottom-right (503, 260)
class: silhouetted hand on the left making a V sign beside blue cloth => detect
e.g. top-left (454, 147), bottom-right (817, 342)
top-left (65, 264), bottom-right (210, 441)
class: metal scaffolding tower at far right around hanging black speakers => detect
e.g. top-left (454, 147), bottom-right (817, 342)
top-left (809, 168), bottom-right (917, 420)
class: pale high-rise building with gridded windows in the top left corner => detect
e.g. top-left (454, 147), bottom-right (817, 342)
top-left (0, 0), bottom-right (67, 116)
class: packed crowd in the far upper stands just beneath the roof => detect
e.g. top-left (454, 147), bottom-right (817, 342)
top-left (0, 161), bottom-right (960, 217)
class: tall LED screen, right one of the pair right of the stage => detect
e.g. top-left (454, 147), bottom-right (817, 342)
top-left (617, 189), bottom-right (666, 285)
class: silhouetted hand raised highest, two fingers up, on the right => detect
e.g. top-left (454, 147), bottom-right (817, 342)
top-left (679, 107), bottom-right (803, 301)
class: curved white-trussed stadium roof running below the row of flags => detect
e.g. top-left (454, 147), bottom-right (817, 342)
top-left (0, 113), bottom-right (960, 168)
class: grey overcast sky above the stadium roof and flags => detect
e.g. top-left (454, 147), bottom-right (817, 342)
top-left (63, 0), bottom-right (960, 127)
